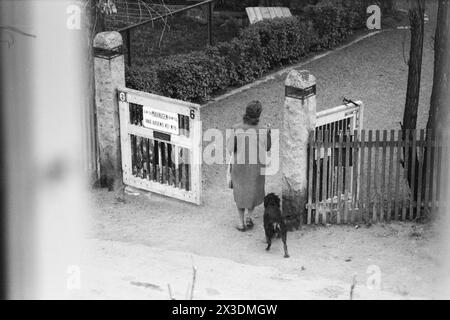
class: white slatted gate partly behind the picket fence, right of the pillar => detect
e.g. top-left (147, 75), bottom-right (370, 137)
top-left (307, 101), bottom-right (364, 223)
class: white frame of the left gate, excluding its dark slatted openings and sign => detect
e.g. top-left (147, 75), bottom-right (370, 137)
top-left (117, 87), bottom-right (202, 205)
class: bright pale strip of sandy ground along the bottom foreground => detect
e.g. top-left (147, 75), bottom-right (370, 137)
top-left (73, 240), bottom-right (426, 300)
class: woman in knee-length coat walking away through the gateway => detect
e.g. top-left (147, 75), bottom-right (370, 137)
top-left (227, 101), bottom-right (271, 231)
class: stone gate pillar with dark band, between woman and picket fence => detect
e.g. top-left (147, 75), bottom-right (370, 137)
top-left (281, 70), bottom-right (316, 228)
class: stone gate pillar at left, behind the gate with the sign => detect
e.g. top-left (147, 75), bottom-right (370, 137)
top-left (94, 31), bottom-right (125, 194)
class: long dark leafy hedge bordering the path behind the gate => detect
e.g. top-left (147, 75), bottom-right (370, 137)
top-left (126, 4), bottom-right (363, 102)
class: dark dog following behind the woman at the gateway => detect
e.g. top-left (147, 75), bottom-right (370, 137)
top-left (264, 193), bottom-right (289, 258)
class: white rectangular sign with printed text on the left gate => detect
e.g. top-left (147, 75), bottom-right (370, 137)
top-left (142, 106), bottom-right (179, 134)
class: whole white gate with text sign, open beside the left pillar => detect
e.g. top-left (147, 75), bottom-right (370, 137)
top-left (118, 88), bottom-right (202, 205)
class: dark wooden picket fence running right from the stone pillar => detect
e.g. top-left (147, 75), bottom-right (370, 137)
top-left (307, 128), bottom-right (448, 224)
